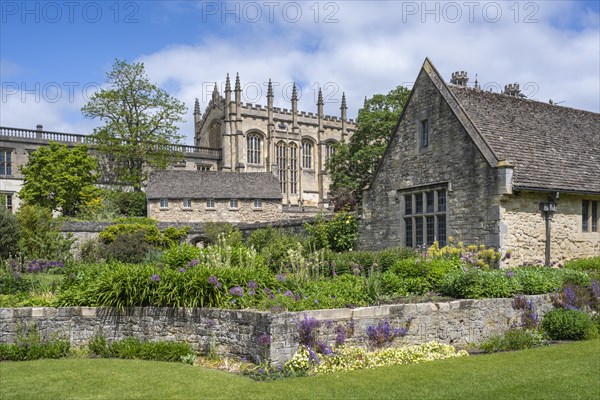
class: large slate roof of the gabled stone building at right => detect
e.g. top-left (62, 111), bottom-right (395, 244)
top-left (448, 83), bottom-right (600, 193)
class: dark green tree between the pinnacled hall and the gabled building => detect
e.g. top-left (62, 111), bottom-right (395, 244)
top-left (327, 86), bottom-right (410, 210)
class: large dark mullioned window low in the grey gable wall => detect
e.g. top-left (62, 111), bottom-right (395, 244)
top-left (403, 188), bottom-right (447, 247)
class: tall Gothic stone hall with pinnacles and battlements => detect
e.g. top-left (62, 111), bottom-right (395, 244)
top-left (194, 75), bottom-right (355, 208)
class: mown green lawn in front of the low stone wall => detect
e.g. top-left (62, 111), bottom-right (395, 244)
top-left (0, 340), bottom-right (600, 400)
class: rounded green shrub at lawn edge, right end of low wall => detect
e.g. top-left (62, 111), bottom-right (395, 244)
top-left (542, 308), bottom-right (598, 340)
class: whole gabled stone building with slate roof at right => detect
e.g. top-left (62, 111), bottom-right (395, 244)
top-left (359, 59), bottom-right (600, 265)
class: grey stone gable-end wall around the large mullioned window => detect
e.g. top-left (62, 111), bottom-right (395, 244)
top-left (359, 70), bottom-right (500, 249)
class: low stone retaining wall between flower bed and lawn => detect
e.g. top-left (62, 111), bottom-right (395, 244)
top-left (0, 295), bottom-right (552, 364)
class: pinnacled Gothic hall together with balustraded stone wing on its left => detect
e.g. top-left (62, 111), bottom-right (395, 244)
top-left (0, 76), bottom-right (355, 213)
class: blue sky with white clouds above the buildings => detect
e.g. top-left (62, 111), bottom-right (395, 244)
top-left (0, 0), bottom-right (600, 144)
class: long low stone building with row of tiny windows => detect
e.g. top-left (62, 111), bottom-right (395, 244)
top-left (146, 171), bottom-right (285, 223)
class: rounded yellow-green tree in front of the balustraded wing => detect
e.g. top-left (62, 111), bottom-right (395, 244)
top-left (19, 142), bottom-right (99, 216)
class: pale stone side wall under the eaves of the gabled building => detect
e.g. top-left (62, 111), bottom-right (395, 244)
top-left (500, 192), bottom-right (600, 266)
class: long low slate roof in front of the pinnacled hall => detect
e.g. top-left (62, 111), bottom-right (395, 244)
top-left (146, 171), bottom-right (282, 200)
